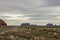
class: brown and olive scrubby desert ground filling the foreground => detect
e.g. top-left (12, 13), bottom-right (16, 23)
top-left (0, 27), bottom-right (60, 40)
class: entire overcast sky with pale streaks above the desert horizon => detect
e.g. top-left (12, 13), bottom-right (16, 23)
top-left (0, 0), bottom-right (60, 25)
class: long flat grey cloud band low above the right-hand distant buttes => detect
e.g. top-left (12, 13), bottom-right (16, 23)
top-left (27, 15), bottom-right (58, 20)
